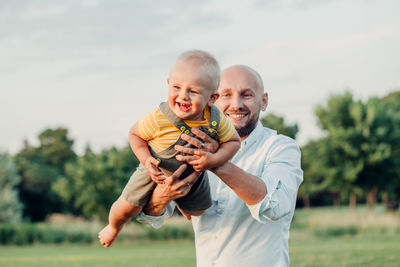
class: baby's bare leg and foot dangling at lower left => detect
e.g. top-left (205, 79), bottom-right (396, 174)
top-left (98, 196), bottom-right (142, 247)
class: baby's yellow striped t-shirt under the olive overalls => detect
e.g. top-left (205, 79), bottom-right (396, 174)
top-left (138, 107), bottom-right (235, 153)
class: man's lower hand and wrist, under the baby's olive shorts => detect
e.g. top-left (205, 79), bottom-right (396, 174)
top-left (143, 164), bottom-right (200, 216)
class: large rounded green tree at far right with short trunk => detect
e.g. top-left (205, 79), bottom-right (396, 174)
top-left (316, 93), bottom-right (400, 210)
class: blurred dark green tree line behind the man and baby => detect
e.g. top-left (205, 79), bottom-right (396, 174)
top-left (0, 91), bottom-right (400, 222)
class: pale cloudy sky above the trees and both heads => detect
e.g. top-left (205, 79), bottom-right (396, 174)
top-left (0, 0), bottom-right (400, 153)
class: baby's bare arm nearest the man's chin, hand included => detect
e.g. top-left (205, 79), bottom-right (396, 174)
top-left (188, 131), bottom-right (240, 172)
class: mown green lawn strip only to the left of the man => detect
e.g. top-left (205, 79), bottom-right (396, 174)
top-left (0, 241), bottom-right (195, 267)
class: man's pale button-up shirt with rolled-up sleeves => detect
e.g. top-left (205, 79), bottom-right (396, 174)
top-left (139, 122), bottom-right (303, 267)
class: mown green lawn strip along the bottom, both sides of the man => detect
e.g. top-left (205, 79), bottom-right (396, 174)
top-left (0, 235), bottom-right (400, 267)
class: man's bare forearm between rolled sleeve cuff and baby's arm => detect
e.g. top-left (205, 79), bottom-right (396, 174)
top-left (212, 161), bottom-right (267, 205)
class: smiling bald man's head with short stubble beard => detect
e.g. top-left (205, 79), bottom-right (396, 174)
top-left (215, 66), bottom-right (268, 139)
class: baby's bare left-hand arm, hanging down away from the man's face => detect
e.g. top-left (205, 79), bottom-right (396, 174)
top-left (129, 123), bottom-right (165, 184)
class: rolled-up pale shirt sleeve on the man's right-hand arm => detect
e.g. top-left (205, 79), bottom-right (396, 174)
top-left (248, 138), bottom-right (303, 223)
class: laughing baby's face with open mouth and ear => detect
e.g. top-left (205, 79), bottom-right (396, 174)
top-left (168, 62), bottom-right (217, 121)
